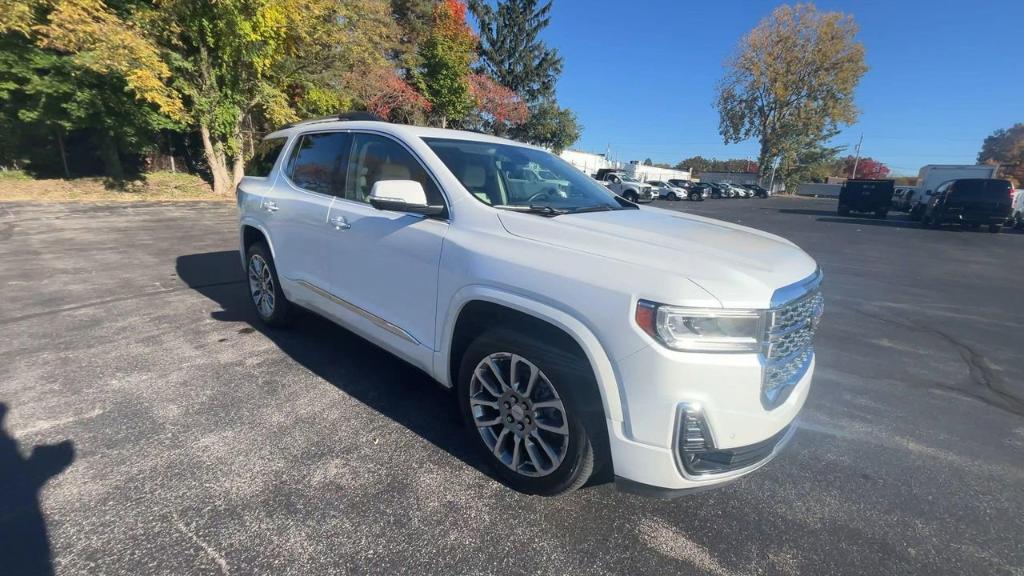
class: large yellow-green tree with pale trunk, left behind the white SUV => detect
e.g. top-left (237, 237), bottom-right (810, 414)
top-left (40, 0), bottom-right (396, 194)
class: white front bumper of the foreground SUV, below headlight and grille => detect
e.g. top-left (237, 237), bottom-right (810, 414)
top-left (607, 346), bottom-right (814, 491)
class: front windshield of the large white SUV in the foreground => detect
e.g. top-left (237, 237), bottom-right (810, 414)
top-left (423, 138), bottom-right (634, 214)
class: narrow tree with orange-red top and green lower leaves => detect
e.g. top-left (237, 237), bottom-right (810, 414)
top-left (416, 0), bottom-right (477, 128)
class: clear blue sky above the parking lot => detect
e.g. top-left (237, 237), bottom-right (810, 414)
top-left (544, 0), bottom-right (1024, 175)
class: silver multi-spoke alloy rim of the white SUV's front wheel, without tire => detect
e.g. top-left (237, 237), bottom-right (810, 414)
top-left (469, 353), bottom-right (569, 478)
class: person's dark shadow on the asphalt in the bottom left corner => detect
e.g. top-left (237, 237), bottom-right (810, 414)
top-left (0, 403), bottom-right (75, 576)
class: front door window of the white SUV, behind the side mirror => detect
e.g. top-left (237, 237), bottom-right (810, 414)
top-left (345, 133), bottom-right (444, 206)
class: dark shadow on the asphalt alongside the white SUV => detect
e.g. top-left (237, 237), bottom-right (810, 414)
top-left (175, 251), bottom-right (614, 484)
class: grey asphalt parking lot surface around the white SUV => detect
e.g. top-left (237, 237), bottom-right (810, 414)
top-left (0, 198), bottom-right (1024, 575)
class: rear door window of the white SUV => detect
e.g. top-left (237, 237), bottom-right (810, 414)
top-left (288, 132), bottom-right (352, 196)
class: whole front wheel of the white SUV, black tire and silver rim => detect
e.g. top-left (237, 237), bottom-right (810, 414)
top-left (458, 328), bottom-right (603, 496)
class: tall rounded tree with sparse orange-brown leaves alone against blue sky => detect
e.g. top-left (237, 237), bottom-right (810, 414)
top-left (716, 4), bottom-right (867, 182)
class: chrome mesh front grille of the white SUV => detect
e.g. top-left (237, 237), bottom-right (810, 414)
top-left (762, 276), bottom-right (824, 408)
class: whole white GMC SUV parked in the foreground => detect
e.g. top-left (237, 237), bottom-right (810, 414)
top-left (238, 115), bottom-right (822, 495)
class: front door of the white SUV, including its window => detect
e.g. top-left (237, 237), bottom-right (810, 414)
top-left (327, 132), bottom-right (449, 369)
